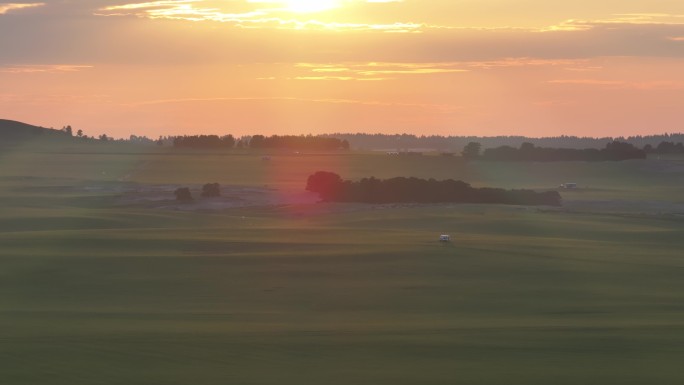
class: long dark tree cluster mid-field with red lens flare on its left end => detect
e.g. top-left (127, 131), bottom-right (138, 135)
top-left (306, 171), bottom-right (561, 206)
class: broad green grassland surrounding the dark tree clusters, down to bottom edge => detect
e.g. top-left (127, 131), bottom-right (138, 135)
top-left (0, 144), bottom-right (684, 385)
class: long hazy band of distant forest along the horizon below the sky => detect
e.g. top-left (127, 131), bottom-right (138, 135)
top-left (159, 134), bottom-right (684, 155)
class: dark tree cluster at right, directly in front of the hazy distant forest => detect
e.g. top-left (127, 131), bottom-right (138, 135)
top-left (481, 141), bottom-right (646, 162)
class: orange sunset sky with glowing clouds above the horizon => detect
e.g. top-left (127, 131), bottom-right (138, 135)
top-left (0, 0), bottom-right (684, 137)
